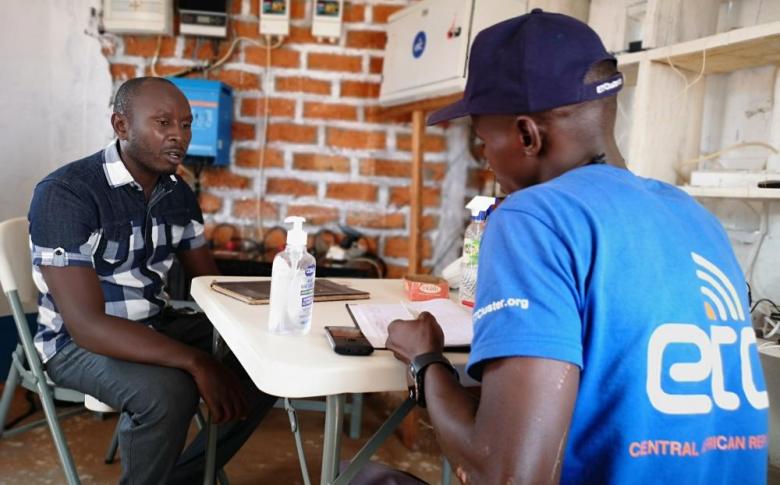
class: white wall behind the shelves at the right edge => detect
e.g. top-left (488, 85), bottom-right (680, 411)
top-left (699, 66), bottom-right (780, 308)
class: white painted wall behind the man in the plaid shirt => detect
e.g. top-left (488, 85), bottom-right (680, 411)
top-left (0, 0), bottom-right (112, 220)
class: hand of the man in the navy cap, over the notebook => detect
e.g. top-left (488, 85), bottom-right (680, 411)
top-left (385, 312), bottom-right (444, 364)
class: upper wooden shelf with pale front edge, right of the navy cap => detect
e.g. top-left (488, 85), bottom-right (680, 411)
top-left (618, 22), bottom-right (780, 74)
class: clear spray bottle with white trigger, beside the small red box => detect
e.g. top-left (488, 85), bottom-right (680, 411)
top-left (458, 195), bottom-right (496, 307)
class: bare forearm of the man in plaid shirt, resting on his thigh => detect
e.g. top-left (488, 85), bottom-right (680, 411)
top-left (66, 315), bottom-right (208, 373)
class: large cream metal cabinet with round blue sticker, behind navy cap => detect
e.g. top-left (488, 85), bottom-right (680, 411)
top-left (379, 0), bottom-right (528, 106)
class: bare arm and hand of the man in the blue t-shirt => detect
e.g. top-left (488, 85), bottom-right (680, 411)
top-left (387, 312), bottom-right (579, 484)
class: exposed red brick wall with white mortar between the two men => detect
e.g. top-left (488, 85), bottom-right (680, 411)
top-left (105, 0), bottom-right (447, 276)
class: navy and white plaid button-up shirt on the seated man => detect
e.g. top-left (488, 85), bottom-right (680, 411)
top-left (28, 142), bottom-right (205, 362)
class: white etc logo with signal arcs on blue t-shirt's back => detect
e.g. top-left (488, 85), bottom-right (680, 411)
top-left (646, 253), bottom-right (769, 414)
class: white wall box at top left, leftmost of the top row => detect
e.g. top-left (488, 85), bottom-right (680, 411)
top-left (103, 0), bottom-right (173, 35)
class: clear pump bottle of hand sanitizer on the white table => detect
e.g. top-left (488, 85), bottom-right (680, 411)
top-left (268, 217), bottom-right (317, 334)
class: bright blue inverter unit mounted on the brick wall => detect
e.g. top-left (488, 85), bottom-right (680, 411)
top-left (169, 78), bottom-right (233, 165)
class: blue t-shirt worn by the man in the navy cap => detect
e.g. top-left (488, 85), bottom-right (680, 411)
top-left (468, 165), bottom-right (768, 483)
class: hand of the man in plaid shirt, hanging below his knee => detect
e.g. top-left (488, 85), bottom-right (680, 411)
top-left (190, 353), bottom-right (249, 424)
